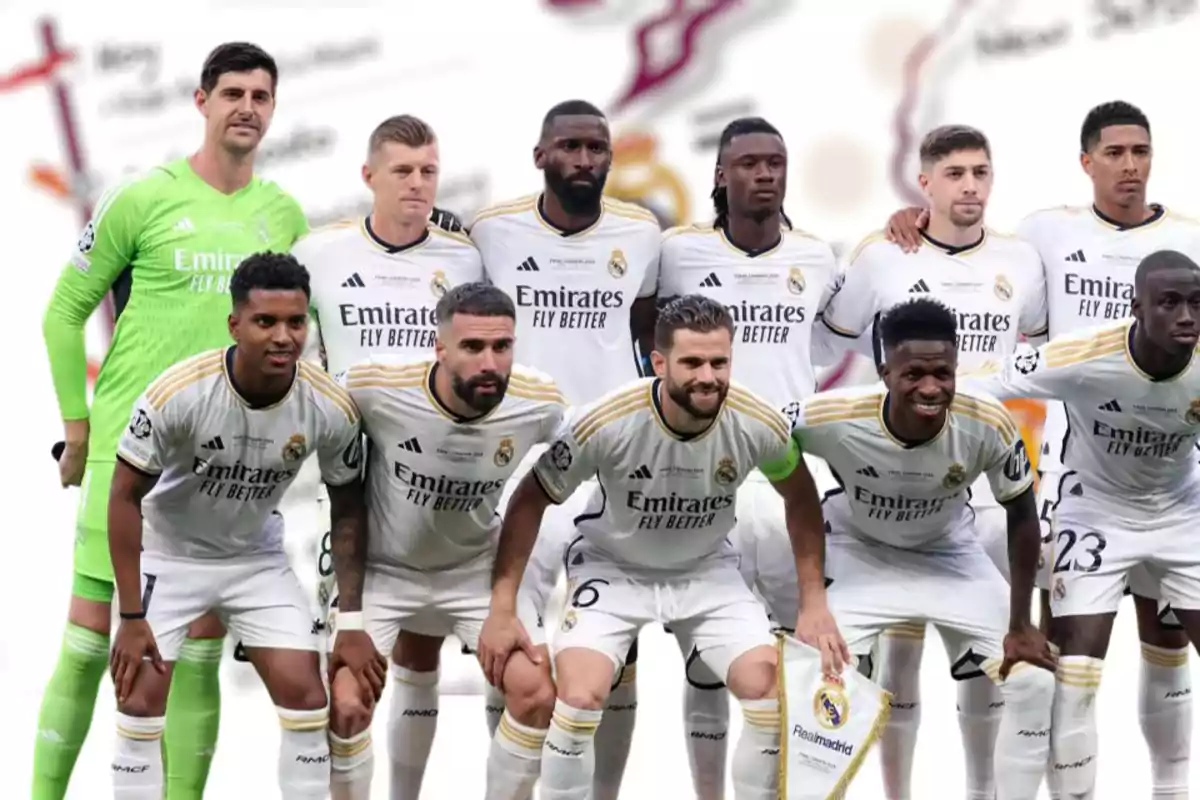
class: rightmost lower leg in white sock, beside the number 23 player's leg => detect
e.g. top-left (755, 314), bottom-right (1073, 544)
top-left (1133, 595), bottom-right (1192, 798)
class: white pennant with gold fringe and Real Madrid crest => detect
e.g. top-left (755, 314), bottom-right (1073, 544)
top-left (779, 634), bottom-right (892, 800)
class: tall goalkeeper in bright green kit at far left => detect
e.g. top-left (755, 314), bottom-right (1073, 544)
top-left (32, 43), bottom-right (307, 800)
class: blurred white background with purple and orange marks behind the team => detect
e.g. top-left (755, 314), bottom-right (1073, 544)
top-left (0, 0), bottom-right (1200, 798)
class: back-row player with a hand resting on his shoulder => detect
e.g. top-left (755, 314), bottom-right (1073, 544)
top-left (822, 125), bottom-right (1046, 800)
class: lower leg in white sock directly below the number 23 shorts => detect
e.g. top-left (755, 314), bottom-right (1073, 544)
top-left (1051, 618), bottom-right (1120, 798)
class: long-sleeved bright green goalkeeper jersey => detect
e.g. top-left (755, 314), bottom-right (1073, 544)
top-left (43, 158), bottom-right (308, 462)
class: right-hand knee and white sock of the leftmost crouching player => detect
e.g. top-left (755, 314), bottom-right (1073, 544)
top-left (246, 646), bottom-right (330, 800)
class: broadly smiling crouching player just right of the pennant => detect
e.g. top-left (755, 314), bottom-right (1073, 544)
top-left (794, 298), bottom-right (1054, 800)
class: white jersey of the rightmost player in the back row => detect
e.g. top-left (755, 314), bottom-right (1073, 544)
top-left (1016, 206), bottom-right (1200, 473)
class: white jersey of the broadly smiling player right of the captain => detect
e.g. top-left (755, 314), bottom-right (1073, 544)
top-left (792, 384), bottom-right (1033, 549)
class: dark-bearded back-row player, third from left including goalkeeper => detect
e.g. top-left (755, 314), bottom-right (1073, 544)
top-left (470, 100), bottom-right (662, 800)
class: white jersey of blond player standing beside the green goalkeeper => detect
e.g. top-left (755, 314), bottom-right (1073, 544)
top-left (292, 218), bottom-right (484, 375)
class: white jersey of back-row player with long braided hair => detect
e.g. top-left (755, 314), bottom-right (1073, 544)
top-left (659, 224), bottom-right (838, 417)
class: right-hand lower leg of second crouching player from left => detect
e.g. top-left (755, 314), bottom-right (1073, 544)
top-left (486, 645), bottom-right (556, 800)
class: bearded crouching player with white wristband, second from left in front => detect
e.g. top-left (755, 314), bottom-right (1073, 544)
top-left (319, 283), bottom-right (565, 800)
